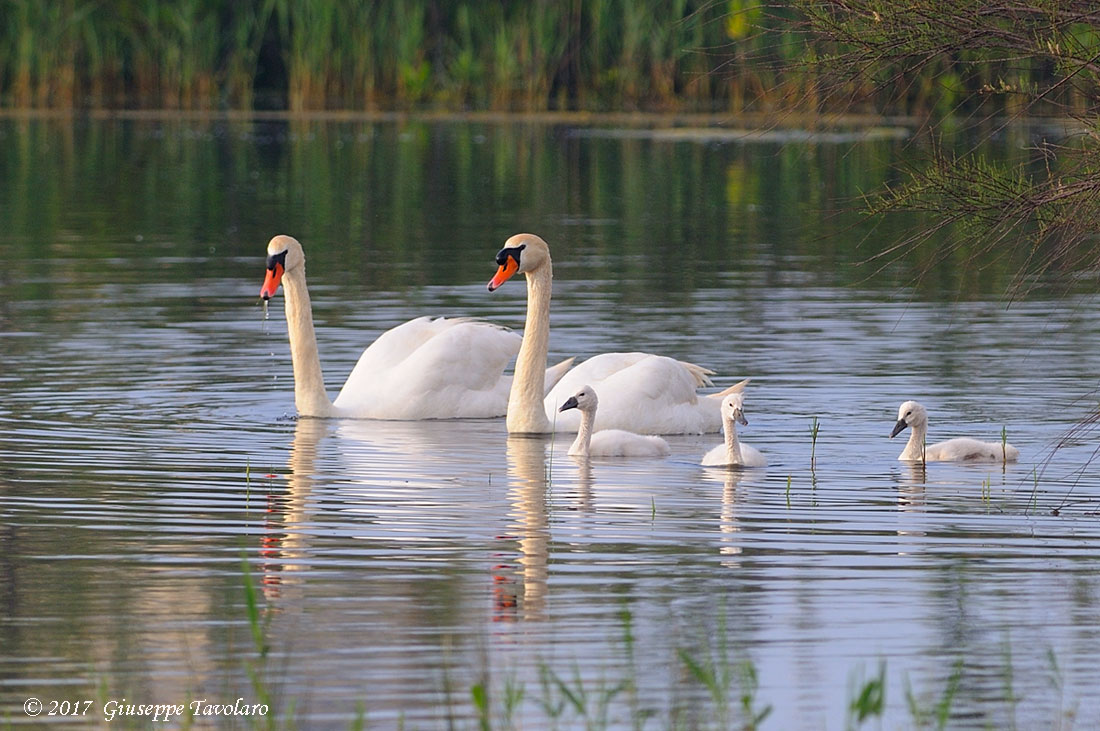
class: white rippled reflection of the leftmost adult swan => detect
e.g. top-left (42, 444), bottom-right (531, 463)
top-left (259, 418), bottom-right (504, 588)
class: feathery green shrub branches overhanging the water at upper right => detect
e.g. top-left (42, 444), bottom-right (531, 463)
top-left (798, 0), bottom-right (1100, 286)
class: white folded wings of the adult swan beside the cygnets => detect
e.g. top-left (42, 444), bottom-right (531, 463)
top-left (543, 353), bottom-right (722, 434)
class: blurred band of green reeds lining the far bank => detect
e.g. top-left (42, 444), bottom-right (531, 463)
top-left (0, 0), bottom-right (1100, 114)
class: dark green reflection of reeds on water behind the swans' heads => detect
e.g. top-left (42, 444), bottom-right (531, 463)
top-left (0, 119), bottom-right (1082, 304)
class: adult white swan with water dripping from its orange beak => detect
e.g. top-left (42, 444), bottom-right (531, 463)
top-left (260, 236), bottom-right (572, 420)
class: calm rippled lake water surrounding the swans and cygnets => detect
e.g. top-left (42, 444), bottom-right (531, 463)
top-left (0, 120), bottom-right (1100, 729)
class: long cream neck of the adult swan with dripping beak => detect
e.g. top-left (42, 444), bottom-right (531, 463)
top-left (283, 267), bottom-right (336, 417)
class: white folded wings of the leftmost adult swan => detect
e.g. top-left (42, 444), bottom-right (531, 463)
top-left (336, 318), bottom-right (520, 419)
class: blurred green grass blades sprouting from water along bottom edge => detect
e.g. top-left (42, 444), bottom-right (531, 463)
top-left (221, 571), bottom-right (1076, 731)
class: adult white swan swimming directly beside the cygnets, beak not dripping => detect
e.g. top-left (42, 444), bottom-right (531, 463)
top-left (488, 233), bottom-right (744, 434)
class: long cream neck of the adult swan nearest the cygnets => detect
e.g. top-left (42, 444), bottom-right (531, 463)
top-left (507, 262), bottom-right (553, 434)
